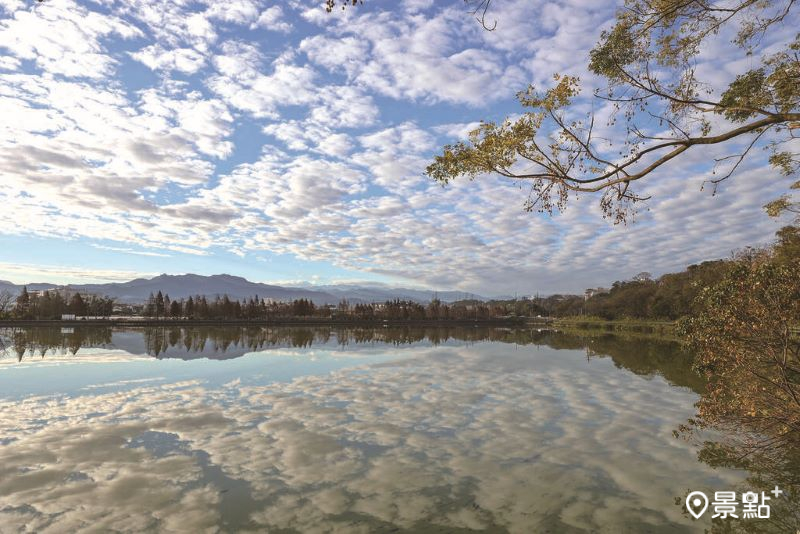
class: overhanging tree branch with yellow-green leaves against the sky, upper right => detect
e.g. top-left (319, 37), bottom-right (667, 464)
top-left (426, 0), bottom-right (800, 222)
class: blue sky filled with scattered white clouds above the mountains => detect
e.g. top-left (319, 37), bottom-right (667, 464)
top-left (0, 0), bottom-right (790, 295)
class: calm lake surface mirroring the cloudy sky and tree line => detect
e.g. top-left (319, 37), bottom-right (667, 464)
top-left (0, 328), bottom-right (746, 532)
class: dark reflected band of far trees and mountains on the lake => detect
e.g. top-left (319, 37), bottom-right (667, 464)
top-left (0, 326), bottom-right (703, 391)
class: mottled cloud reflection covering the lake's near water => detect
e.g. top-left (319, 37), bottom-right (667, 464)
top-left (0, 343), bottom-right (744, 532)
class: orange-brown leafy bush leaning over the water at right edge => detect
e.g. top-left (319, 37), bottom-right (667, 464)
top-left (679, 251), bottom-right (800, 485)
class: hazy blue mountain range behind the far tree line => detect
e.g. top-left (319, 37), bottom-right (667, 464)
top-left (0, 274), bottom-right (487, 305)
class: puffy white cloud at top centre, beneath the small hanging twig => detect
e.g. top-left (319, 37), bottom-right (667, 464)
top-left (301, 8), bottom-right (527, 106)
